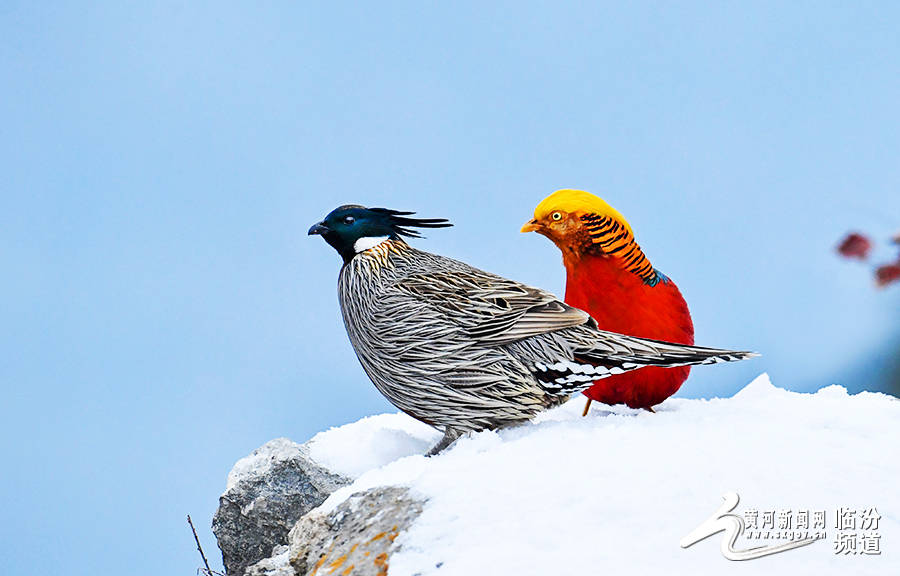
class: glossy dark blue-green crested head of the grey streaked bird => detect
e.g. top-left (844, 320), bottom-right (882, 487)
top-left (309, 204), bottom-right (453, 263)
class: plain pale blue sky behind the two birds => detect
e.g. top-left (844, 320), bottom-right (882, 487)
top-left (0, 2), bottom-right (900, 576)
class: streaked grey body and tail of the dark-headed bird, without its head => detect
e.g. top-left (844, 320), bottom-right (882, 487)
top-left (338, 237), bottom-right (752, 452)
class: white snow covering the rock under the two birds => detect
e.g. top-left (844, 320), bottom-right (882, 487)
top-left (310, 375), bottom-right (900, 576)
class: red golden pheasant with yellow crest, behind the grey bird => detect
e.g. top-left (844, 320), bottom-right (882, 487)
top-left (522, 190), bottom-right (694, 414)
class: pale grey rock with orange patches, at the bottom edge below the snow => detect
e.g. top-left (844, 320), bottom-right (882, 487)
top-left (290, 486), bottom-right (424, 576)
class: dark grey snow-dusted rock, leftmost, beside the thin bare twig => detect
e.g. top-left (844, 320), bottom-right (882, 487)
top-left (212, 438), bottom-right (350, 576)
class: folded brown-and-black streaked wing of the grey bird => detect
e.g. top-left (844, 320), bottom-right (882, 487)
top-left (396, 255), bottom-right (591, 345)
